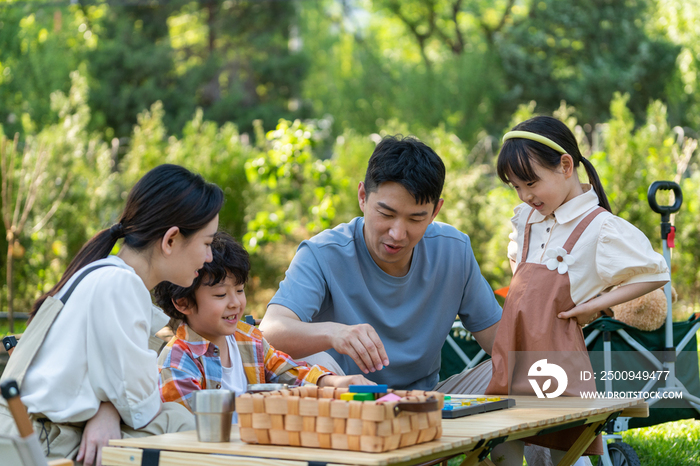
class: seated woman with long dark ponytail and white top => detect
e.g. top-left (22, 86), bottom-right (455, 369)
top-left (0, 165), bottom-right (223, 465)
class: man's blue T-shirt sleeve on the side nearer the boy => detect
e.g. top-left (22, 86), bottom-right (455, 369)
top-left (270, 241), bottom-right (329, 322)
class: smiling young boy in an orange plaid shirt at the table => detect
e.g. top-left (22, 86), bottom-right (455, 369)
top-left (154, 232), bottom-right (373, 411)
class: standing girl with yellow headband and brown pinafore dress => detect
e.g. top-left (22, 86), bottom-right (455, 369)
top-left (486, 116), bottom-right (670, 466)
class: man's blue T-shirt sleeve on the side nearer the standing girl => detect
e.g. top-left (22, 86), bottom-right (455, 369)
top-left (459, 238), bottom-right (503, 332)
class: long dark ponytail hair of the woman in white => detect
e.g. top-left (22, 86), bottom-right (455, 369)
top-left (32, 164), bottom-right (224, 316)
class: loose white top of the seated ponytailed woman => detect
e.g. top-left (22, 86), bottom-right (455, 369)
top-left (22, 256), bottom-right (168, 429)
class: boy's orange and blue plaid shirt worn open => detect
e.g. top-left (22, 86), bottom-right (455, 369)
top-left (158, 321), bottom-right (332, 411)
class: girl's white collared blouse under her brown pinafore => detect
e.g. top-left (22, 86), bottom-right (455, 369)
top-left (508, 185), bottom-right (670, 304)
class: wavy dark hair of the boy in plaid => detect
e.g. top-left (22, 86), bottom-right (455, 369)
top-left (153, 231), bottom-right (250, 324)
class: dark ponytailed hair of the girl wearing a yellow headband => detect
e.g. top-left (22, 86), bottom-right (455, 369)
top-left (496, 116), bottom-right (610, 212)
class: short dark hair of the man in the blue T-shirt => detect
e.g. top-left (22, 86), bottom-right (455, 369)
top-left (365, 135), bottom-right (445, 204)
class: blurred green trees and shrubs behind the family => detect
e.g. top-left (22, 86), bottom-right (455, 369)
top-left (0, 0), bottom-right (700, 328)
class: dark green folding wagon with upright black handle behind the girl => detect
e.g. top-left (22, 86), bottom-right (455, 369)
top-left (584, 181), bottom-right (700, 466)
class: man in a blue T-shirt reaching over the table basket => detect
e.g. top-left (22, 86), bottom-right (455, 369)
top-left (260, 137), bottom-right (501, 393)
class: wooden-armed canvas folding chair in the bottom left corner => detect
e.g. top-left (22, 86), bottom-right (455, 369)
top-left (0, 380), bottom-right (73, 466)
